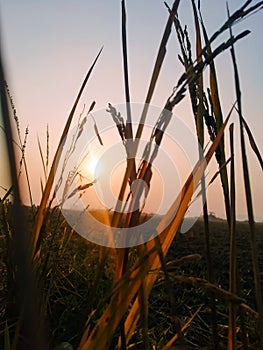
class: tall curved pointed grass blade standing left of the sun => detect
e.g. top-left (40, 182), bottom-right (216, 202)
top-left (33, 48), bottom-right (103, 255)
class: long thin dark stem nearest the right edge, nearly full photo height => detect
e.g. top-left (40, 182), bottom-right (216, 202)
top-left (228, 2), bottom-right (263, 346)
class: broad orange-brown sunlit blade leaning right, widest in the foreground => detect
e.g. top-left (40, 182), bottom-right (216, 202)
top-left (80, 110), bottom-right (230, 350)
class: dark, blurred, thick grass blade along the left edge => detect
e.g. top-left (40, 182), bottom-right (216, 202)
top-left (0, 37), bottom-right (48, 350)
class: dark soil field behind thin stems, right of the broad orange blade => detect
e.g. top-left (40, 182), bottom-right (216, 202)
top-left (146, 217), bottom-right (263, 349)
